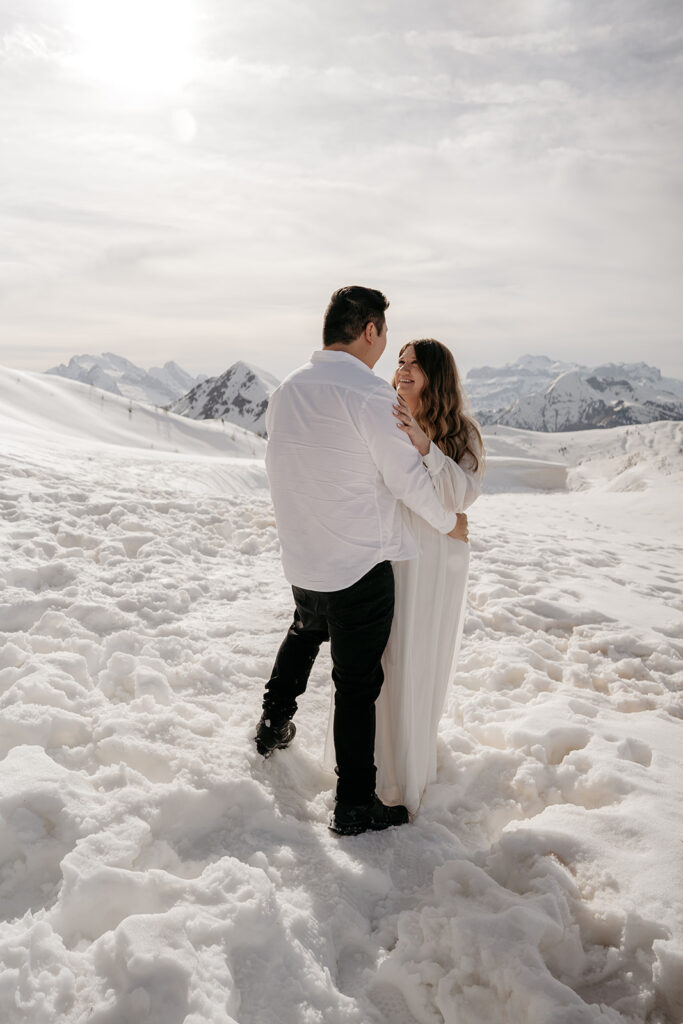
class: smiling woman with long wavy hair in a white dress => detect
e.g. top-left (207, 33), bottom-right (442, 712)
top-left (375, 339), bottom-right (484, 814)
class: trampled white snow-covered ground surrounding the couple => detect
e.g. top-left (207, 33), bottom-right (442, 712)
top-left (0, 371), bottom-right (683, 1024)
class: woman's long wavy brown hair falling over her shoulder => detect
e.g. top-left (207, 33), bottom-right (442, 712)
top-left (391, 338), bottom-right (483, 470)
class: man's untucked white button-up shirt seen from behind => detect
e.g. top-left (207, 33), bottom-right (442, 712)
top-left (265, 349), bottom-right (457, 591)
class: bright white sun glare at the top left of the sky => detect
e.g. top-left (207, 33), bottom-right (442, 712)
top-left (69, 0), bottom-right (197, 100)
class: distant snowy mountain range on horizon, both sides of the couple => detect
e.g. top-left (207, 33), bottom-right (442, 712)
top-left (47, 352), bottom-right (683, 437)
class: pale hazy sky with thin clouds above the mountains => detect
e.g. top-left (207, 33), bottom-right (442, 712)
top-left (0, 0), bottom-right (683, 378)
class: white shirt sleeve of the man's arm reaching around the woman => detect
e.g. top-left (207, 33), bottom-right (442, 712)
top-left (359, 384), bottom-right (457, 534)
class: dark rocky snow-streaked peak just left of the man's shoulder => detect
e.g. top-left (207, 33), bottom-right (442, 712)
top-left (171, 361), bottom-right (280, 437)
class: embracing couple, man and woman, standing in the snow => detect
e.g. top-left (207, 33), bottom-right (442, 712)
top-left (256, 286), bottom-right (483, 836)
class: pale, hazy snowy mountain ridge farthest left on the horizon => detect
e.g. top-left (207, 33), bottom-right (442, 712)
top-left (47, 352), bottom-right (206, 406)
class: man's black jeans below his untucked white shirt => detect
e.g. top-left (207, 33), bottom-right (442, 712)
top-left (263, 562), bottom-right (394, 804)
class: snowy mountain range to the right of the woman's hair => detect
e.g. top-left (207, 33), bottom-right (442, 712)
top-left (465, 355), bottom-right (683, 431)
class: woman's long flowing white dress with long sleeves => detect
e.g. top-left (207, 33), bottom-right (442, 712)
top-left (325, 442), bottom-right (483, 814)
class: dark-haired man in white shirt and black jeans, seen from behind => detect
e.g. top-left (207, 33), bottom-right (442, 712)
top-left (256, 286), bottom-right (471, 836)
